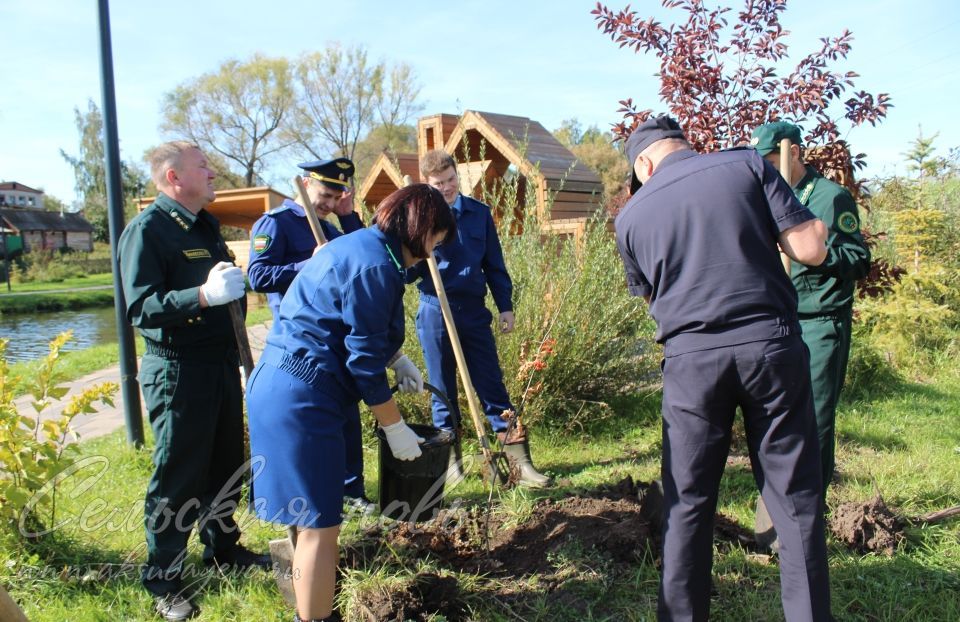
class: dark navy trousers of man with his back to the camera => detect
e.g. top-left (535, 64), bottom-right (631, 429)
top-left (658, 336), bottom-right (830, 622)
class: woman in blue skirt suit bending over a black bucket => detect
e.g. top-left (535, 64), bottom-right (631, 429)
top-left (247, 184), bottom-right (456, 622)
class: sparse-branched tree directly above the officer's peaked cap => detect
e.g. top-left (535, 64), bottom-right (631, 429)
top-left (289, 43), bottom-right (423, 176)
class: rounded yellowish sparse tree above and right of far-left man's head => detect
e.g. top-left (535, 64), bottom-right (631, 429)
top-left (160, 54), bottom-right (295, 187)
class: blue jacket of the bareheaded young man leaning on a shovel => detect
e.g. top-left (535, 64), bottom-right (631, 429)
top-left (410, 195), bottom-right (513, 313)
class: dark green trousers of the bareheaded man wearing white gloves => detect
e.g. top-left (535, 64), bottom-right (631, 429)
top-left (139, 354), bottom-right (244, 595)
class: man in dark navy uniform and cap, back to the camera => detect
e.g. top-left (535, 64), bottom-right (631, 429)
top-left (615, 116), bottom-right (831, 622)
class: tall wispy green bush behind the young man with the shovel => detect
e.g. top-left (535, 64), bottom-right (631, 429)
top-left (386, 158), bottom-right (660, 430)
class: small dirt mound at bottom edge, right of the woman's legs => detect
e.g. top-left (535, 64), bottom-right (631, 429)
top-left (354, 573), bottom-right (468, 622)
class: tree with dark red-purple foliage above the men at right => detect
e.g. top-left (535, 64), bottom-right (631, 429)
top-left (591, 0), bottom-right (892, 196)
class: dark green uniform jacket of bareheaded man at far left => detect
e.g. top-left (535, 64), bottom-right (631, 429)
top-left (118, 193), bottom-right (236, 350)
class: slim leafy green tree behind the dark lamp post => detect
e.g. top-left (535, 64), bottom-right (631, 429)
top-left (60, 100), bottom-right (147, 242)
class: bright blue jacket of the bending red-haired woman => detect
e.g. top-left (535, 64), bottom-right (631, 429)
top-left (267, 226), bottom-right (405, 405)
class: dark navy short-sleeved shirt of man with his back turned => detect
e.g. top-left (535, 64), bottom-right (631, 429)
top-left (614, 149), bottom-right (815, 356)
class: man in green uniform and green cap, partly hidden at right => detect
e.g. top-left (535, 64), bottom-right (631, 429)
top-left (751, 121), bottom-right (870, 499)
